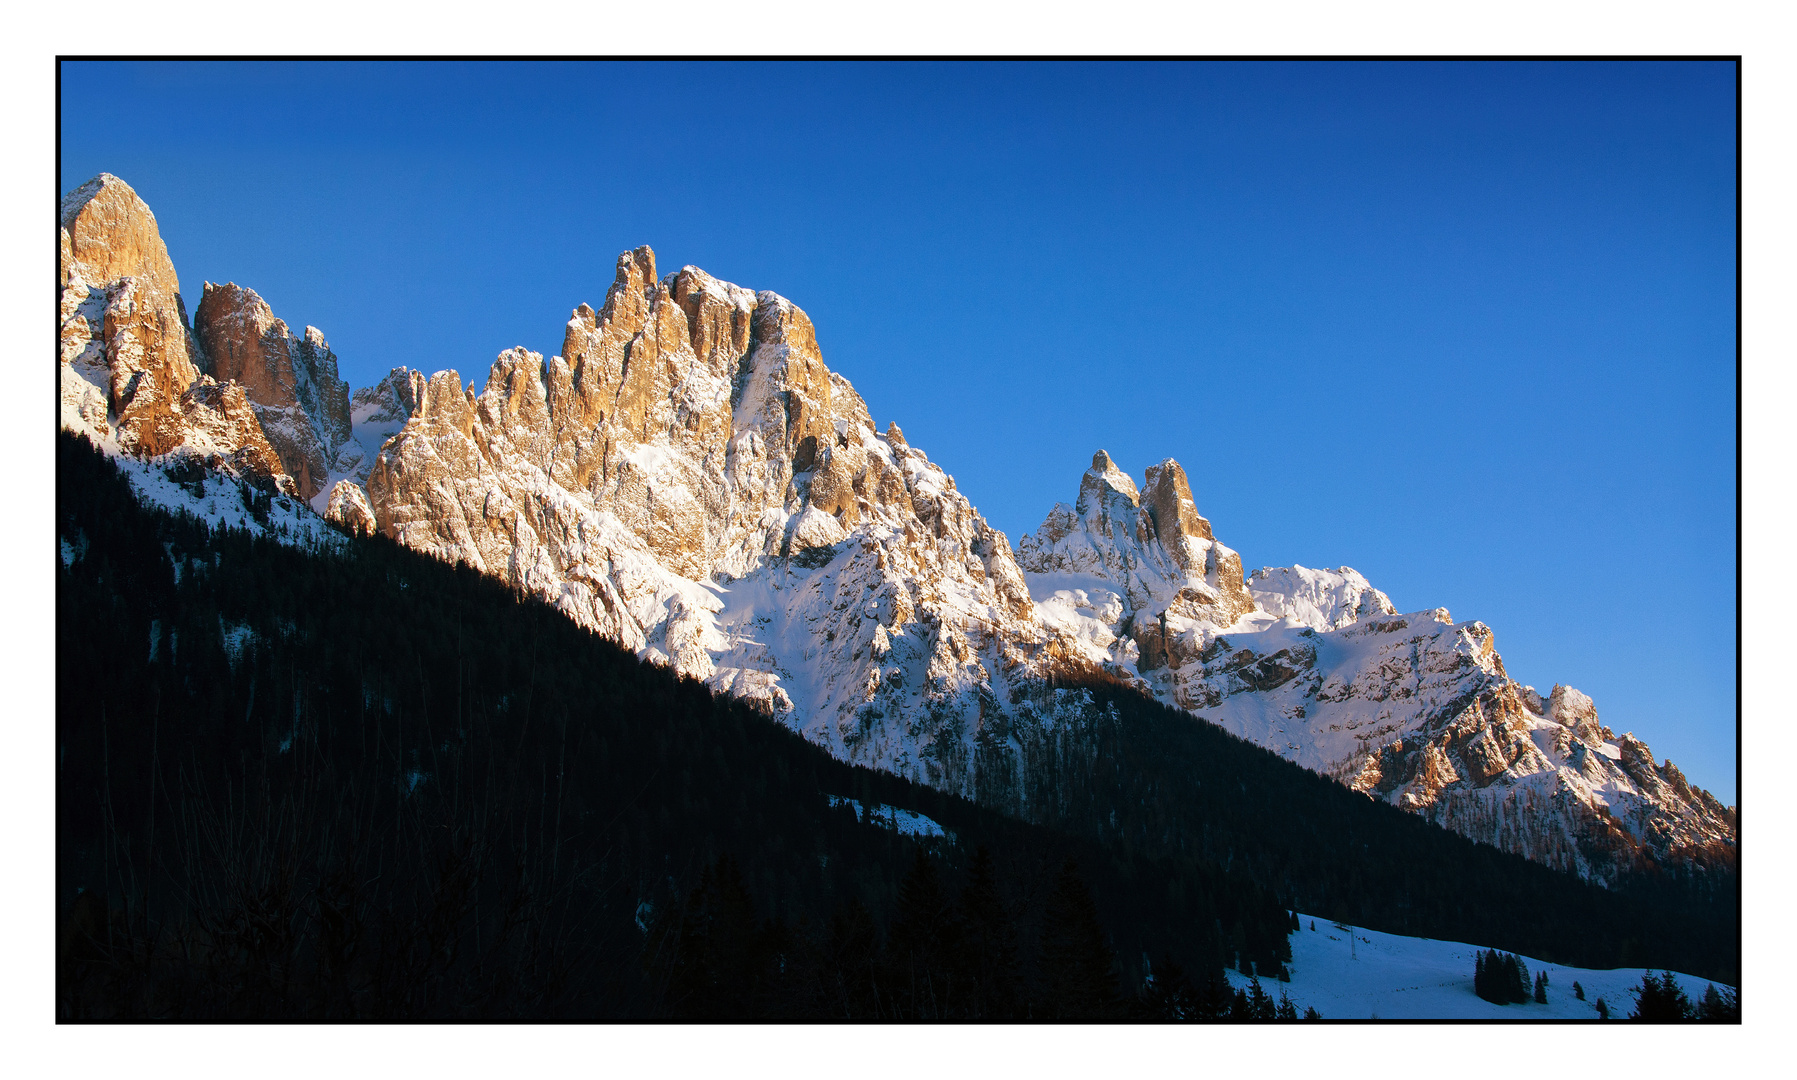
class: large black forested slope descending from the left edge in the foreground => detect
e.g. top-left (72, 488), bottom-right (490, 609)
top-left (56, 435), bottom-right (1290, 1019)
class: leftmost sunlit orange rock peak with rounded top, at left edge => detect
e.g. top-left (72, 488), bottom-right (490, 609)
top-left (58, 173), bottom-right (293, 491)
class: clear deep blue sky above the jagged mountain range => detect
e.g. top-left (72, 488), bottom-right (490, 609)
top-left (59, 63), bottom-right (1736, 801)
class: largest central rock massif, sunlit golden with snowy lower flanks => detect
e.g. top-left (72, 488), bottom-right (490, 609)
top-left (367, 248), bottom-right (1044, 792)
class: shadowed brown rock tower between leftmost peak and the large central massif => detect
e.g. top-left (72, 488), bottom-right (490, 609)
top-left (194, 282), bottom-right (350, 500)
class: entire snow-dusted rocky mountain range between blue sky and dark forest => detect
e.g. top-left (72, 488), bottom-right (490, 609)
top-left (59, 174), bottom-right (1738, 881)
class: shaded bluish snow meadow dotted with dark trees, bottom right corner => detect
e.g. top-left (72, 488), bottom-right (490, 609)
top-left (1229, 915), bottom-right (1732, 1021)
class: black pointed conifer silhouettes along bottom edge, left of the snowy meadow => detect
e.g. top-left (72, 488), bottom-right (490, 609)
top-left (647, 848), bottom-right (1317, 1021)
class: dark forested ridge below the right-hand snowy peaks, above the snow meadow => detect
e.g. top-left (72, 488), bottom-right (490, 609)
top-left (1006, 676), bottom-right (1741, 985)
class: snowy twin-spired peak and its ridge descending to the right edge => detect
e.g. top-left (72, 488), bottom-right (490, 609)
top-left (1019, 451), bottom-right (1736, 879)
